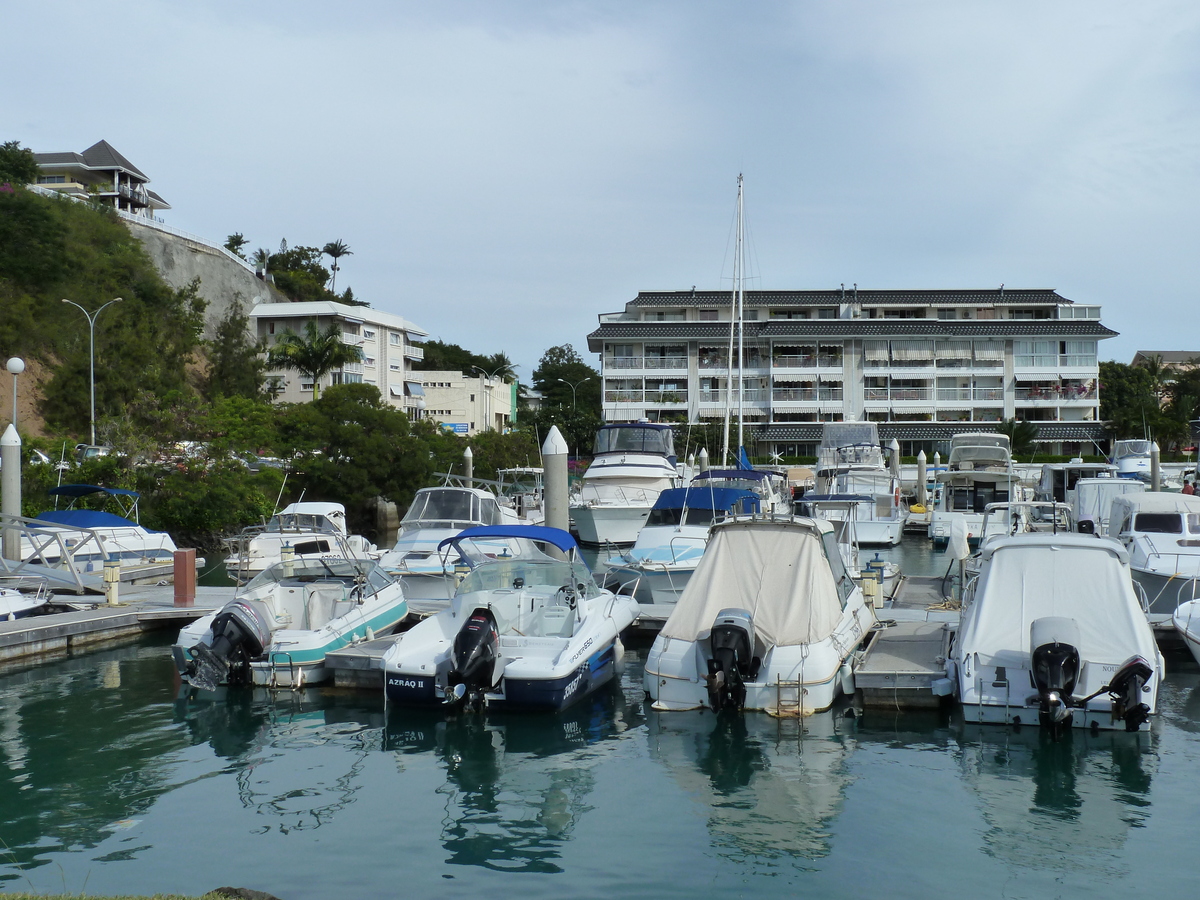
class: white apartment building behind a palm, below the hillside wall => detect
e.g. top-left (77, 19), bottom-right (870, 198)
top-left (250, 300), bottom-right (428, 419)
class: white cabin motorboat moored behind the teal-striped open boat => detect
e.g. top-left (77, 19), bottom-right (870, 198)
top-left (224, 500), bottom-right (379, 583)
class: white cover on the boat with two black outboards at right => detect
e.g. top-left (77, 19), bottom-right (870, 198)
top-left (959, 534), bottom-right (1157, 667)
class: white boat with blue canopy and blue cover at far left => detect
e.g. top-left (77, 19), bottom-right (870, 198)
top-left (22, 485), bottom-right (175, 569)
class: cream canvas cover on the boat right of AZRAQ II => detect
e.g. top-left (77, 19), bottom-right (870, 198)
top-left (662, 520), bottom-right (841, 647)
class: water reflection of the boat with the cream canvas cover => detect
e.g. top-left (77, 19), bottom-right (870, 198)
top-left (649, 712), bottom-right (857, 871)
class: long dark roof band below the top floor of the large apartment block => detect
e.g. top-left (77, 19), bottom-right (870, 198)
top-left (588, 319), bottom-right (1118, 353)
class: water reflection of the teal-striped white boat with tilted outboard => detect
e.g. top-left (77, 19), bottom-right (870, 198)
top-left (174, 685), bottom-right (383, 834)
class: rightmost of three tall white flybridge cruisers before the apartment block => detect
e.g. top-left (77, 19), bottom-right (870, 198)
top-left (929, 432), bottom-right (1024, 550)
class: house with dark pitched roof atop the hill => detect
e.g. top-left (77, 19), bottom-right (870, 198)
top-left (34, 140), bottom-right (170, 218)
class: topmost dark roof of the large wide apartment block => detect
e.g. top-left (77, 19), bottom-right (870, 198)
top-left (631, 288), bottom-right (1072, 307)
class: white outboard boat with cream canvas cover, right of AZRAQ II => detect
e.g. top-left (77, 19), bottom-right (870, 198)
top-left (644, 515), bottom-right (875, 715)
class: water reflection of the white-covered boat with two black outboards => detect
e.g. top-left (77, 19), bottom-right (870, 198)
top-left (958, 725), bottom-right (1158, 874)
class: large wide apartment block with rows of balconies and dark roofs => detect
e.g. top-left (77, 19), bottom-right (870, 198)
top-left (588, 287), bottom-right (1116, 456)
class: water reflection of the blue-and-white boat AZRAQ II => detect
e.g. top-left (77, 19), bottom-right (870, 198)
top-left (384, 689), bottom-right (641, 872)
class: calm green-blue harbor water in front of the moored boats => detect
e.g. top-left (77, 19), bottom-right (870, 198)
top-left (0, 541), bottom-right (1200, 900)
